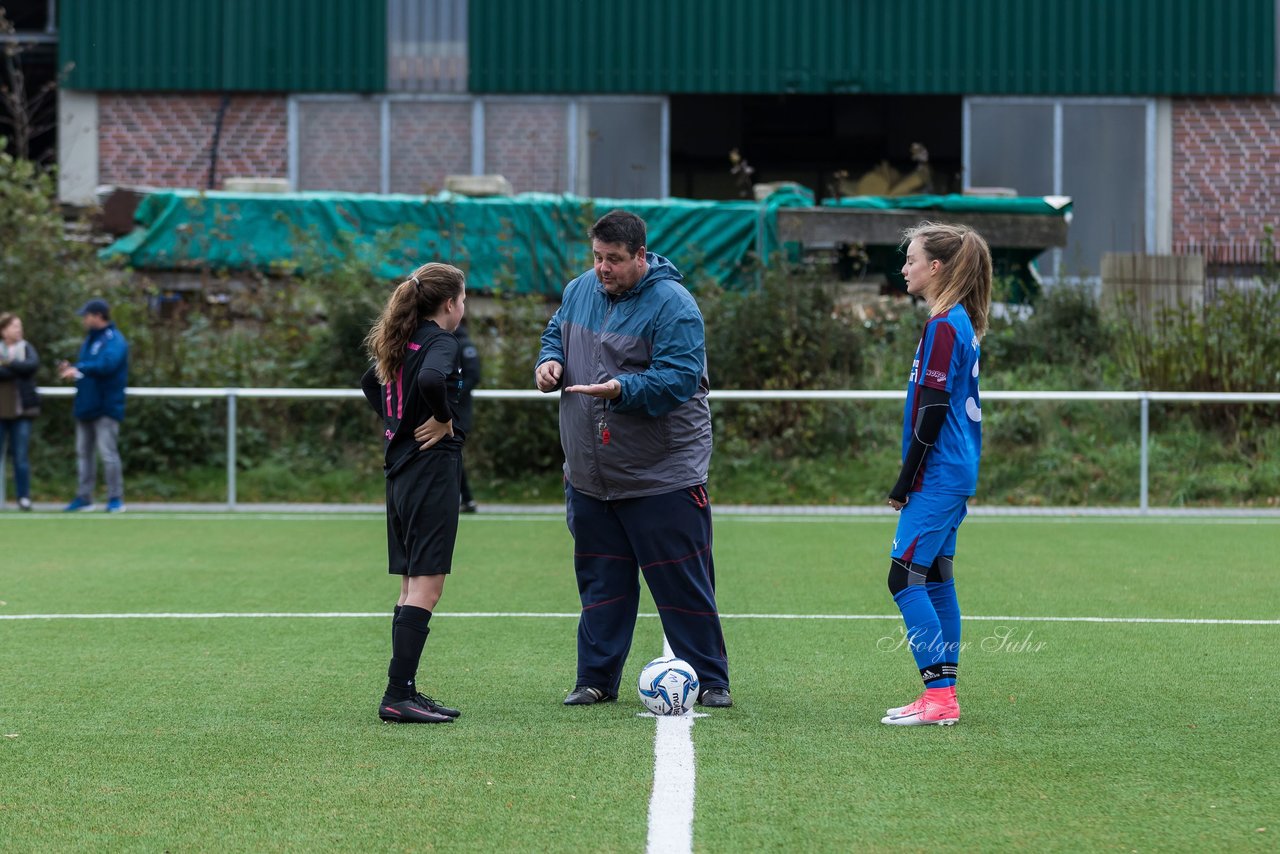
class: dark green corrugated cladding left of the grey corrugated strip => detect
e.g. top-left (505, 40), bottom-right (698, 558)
top-left (59, 0), bottom-right (387, 92)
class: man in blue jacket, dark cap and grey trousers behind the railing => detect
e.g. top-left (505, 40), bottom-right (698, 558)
top-left (58, 300), bottom-right (129, 513)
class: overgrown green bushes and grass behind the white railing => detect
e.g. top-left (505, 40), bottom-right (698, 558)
top-left (0, 156), bottom-right (1280, 506)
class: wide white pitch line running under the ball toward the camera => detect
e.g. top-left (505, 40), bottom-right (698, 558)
top-left (645, 635), bottom-right (696, 854)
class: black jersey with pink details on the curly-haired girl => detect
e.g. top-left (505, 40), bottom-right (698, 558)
top-left (360, 320), bottom-right (465, 478)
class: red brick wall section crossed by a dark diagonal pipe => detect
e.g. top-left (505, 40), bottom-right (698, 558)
top-left (99, 93), bottom-right (288, 189)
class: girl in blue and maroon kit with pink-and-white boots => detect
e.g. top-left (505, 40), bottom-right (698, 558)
top-left (881, 223), bottom-right (991, 726)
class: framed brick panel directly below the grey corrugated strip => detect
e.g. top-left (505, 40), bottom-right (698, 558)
top-left (390, 101), bottom-right (471, 195)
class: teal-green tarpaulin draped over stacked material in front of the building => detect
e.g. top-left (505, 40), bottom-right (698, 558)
top-left (101, 187), bottom-right (1070, 296)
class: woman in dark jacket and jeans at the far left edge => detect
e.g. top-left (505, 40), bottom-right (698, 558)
top-left (0, 311), bottom-right (40, 511)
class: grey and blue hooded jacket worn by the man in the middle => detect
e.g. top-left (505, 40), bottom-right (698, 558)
top-left (538, 252), bottom-right (712, 501)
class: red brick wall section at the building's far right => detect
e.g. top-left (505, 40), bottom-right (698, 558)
top-left (1172, 97), bottom-right (1280, 243)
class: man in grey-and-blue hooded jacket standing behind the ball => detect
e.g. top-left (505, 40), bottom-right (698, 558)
top-left (534, 210), bottom-right (733, 707)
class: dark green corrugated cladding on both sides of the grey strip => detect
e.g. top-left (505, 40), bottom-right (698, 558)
top-left (59, 0), bottom-right (1276, 95)
